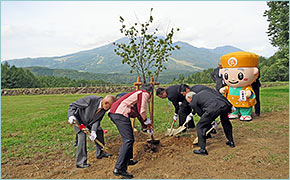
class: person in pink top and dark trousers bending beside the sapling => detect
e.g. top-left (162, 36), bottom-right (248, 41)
top-left (109, 84), bottom-right (153, 179)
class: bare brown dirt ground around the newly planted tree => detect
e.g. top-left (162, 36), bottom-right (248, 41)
top-left (1, 111), bottom-right (289, 179)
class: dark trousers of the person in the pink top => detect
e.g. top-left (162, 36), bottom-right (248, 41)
top-left (109, 113), bottom-right (134, 171)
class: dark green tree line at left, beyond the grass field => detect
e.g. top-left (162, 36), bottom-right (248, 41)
top-left (1, 62), bottom-right (109, 89)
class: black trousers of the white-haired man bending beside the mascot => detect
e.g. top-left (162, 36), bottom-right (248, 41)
top-left (196, 105), bottom-right (233, 149)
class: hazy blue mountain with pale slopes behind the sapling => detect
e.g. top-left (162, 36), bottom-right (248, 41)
top-left (3, 38), bottom-right (242, 74)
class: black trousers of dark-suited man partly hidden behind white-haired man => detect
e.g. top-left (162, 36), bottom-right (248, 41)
top-left (178, 100), bottom-right (195, 128)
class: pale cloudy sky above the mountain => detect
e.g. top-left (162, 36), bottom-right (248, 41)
top-left (1, 1), bottom-right (277, 60)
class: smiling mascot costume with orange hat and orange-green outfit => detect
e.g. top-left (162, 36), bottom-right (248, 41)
top-left (220, 52), bottom-right (259, 121)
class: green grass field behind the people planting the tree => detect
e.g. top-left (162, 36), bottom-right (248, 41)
top-left (1, 85), bottom-right (289, 163)
